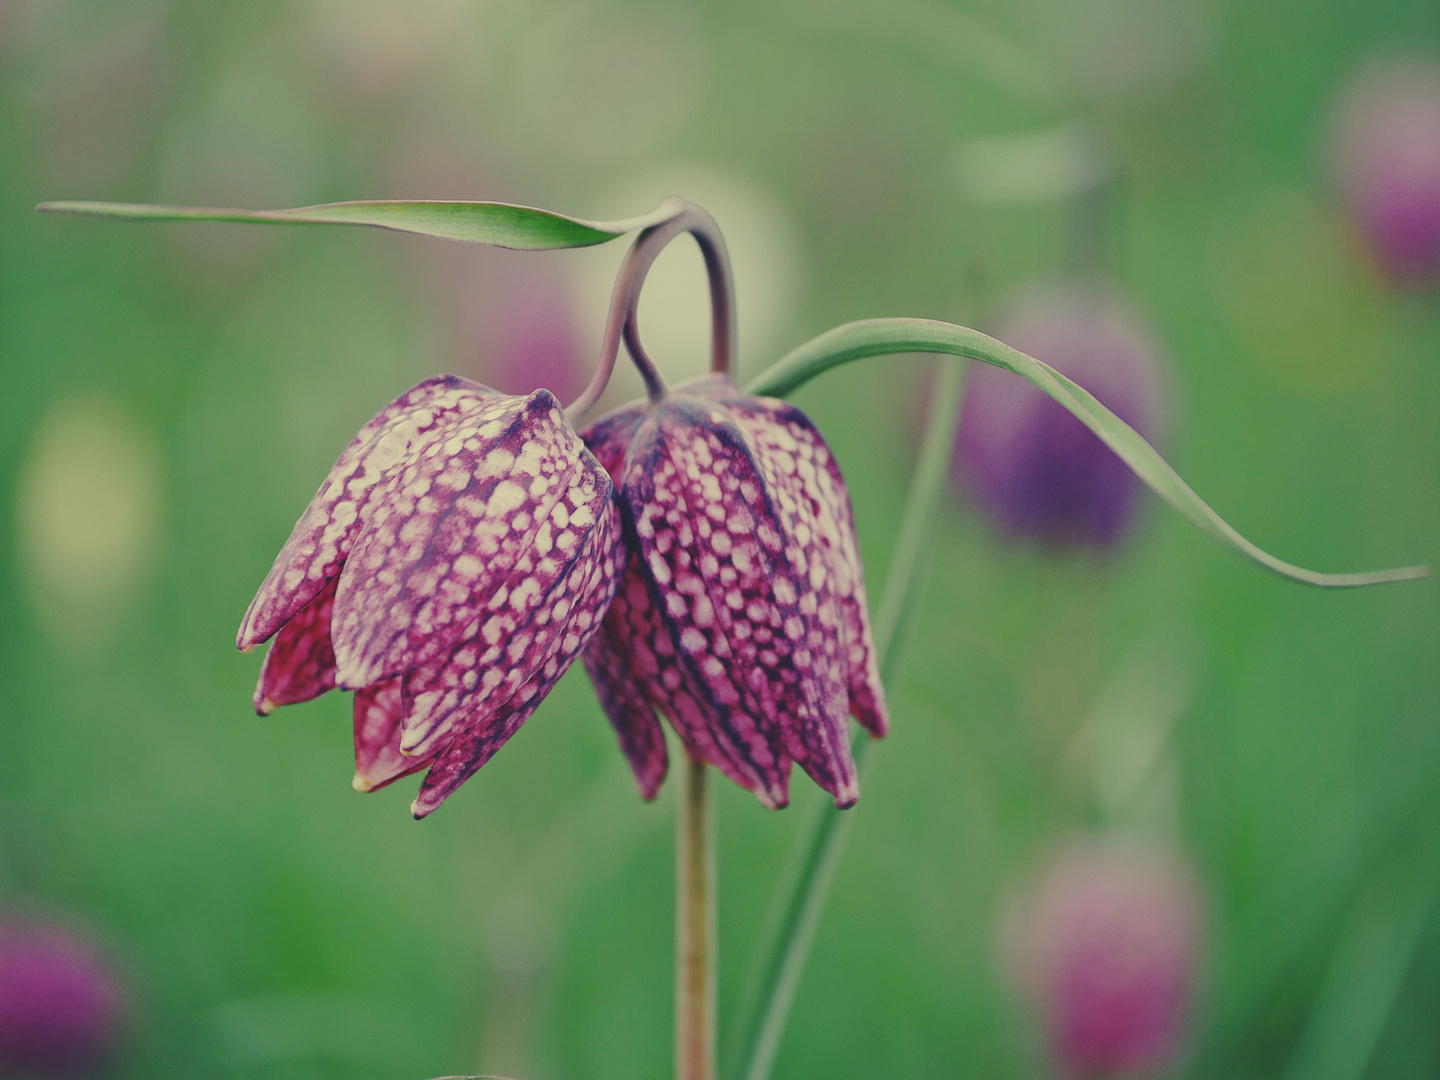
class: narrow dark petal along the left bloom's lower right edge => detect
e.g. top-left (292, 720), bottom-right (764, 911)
top-left (410, 504), bottom-right (625, 818)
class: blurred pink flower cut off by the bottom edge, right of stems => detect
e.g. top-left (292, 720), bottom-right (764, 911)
top-left (1005, 841), bottom-right (1201, 1080)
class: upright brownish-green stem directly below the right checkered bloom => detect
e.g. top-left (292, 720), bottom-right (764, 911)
top-left (675, 755), bottom-right (716, 1080)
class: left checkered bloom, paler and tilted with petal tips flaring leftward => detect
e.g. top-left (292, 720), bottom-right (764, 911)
top-left (238, 376), bottom-right (625, 818)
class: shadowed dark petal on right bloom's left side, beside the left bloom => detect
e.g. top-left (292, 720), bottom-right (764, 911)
top-left (582, 566), bottom-right (670, 801)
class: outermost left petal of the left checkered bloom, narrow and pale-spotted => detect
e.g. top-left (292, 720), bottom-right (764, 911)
top-left (236, 374), bottom-right (498, 651)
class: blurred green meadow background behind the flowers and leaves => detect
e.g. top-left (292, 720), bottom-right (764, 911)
top-left (0, 0), bottom-right (1440, 1080)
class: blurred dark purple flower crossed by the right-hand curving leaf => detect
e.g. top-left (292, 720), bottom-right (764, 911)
top-left (955, 285), bottom-right (1161, 550)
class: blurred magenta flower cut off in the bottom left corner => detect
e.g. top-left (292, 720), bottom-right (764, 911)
top-left (0, 916), bottom-right (124, 1080)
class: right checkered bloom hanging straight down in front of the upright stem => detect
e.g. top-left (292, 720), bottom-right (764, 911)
top-left (582, 376), bottom-right (887, 808)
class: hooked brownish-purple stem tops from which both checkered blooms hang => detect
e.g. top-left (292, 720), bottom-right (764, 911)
top-left (564, 199), bottom-right (734, 423)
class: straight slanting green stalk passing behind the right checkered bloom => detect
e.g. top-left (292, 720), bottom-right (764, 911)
top-left (726, 357), bottom-right (965, 1080)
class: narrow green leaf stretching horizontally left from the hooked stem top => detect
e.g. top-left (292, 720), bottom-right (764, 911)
top-left (35, 197), bottom-right (684, 251)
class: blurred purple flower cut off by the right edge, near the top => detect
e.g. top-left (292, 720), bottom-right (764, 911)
top-left (1328, 58), bottom-right (1440, 282)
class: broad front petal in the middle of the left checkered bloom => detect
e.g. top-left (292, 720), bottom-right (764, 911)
top-left (333, 390), bottom-right (611, 687)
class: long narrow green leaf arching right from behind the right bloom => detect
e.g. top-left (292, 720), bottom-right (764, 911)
top-left (747, 318), bottom-right (1430, 589)
